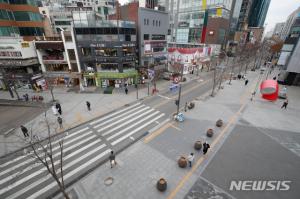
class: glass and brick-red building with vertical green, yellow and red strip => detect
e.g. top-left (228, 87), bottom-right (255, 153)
top-left (168, 0), bottom-right (232, 44)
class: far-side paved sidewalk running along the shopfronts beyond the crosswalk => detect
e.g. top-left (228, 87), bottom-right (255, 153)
top-left (0, 72), bottom-right (208, 157)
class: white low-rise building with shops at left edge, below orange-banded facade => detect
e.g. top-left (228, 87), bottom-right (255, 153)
top-left (0, 37), bottom-right (42, 89)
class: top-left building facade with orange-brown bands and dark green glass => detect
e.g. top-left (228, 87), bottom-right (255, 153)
top-left (0, 0), bottom-right (44, 40)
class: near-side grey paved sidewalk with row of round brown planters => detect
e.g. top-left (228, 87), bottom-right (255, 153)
top-left (49, 68), bottom-right (300, 199)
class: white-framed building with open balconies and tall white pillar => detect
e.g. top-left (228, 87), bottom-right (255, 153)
top-left (34, 31), bottom-right (81, 87)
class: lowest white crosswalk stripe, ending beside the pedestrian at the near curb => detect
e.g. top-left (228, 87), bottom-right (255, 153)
top-left (24, 149), bottom-right (111, 199)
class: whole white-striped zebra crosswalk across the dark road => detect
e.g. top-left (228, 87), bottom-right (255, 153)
top-left (0, 103), bottom-right (166, 199)
